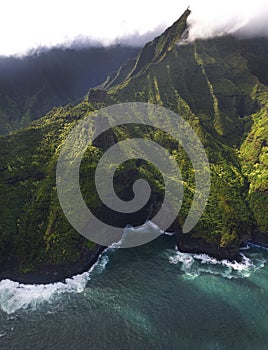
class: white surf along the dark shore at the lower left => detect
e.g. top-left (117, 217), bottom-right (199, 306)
top-left (0, 248), bottom-right (110, 314)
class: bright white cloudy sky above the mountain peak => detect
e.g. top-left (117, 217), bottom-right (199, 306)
top-left (0, 0), bottom-right (268, 56)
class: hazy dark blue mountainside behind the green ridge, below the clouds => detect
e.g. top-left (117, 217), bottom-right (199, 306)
top-left (0, 46), bottom-right (139, 133)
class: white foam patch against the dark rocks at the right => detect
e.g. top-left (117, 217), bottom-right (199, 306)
top-left (169, 250), bottom-right (266, 279)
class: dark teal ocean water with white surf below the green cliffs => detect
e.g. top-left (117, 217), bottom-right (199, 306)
top-left (0, 223), bottom-right (268, 350)
